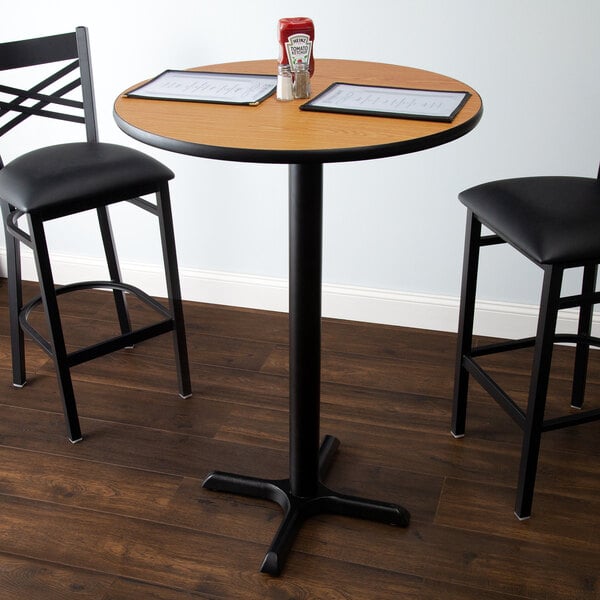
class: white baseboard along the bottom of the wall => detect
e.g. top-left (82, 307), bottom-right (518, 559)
top-left (0, 248), bottom-right (600, 338)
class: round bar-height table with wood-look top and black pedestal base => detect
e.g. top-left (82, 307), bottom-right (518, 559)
top-left (114, 59), bottom-right (483, 575)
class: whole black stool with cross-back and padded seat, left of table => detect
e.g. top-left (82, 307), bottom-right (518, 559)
top-left (0, 27), bottom-right (191, 442)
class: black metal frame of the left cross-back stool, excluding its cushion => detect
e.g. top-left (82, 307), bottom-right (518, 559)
top-left (0, 27), bottom-right (191, 443)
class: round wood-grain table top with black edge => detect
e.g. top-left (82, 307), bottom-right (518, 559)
top-left (114, 59), bottom-right (483, 163)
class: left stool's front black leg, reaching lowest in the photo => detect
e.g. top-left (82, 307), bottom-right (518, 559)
top-left (29, 215), bottom-right (82, 443)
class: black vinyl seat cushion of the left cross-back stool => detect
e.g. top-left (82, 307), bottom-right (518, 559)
top-left (0, 142), bottom-right (174, 214)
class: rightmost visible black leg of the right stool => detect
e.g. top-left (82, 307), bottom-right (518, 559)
top-left (571, 265), bottom-right (598, 408)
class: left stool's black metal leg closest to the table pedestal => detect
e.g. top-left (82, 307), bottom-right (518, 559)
top-left (156, 183), bottom-right (192, 398)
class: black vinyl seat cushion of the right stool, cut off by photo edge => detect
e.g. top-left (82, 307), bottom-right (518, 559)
top-left (459, 177), bottom-right (600, 264)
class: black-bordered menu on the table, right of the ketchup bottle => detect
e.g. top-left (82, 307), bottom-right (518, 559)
top-left (300, 82), bottom-right (471, 123)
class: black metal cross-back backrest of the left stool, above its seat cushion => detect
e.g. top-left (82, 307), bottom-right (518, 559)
top-left (0, 27), bottom-right (98, 167)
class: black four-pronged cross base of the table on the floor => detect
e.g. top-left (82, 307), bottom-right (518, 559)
top-left (202, 435), bottom-right (410, 575)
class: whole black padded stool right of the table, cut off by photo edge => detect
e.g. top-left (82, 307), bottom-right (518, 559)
top-left (452, 163), bottom-right (600, 519)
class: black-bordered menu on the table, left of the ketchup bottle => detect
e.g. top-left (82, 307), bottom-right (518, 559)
top-left (127, 69), bottom-right (277, 106)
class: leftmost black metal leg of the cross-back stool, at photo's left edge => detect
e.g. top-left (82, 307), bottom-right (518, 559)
top-left (2, 202), bottom-right (27, 387)
